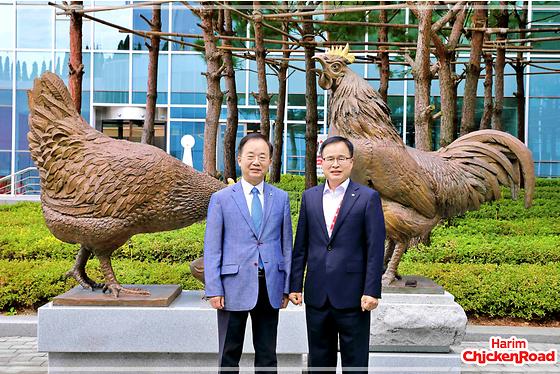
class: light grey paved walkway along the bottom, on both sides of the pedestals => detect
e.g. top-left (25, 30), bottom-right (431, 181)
top-left (0, 337), bottom-right (560, 374)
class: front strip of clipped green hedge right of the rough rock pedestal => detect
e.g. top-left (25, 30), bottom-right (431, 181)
top-left (399, 261), bottom-right (560, 320)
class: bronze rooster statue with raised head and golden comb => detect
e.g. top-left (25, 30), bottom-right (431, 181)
top-left (315, 45), bottom-right (535, 285)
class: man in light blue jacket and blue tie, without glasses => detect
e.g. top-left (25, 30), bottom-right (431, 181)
top-left (204, 133), bottom-right (292, 372)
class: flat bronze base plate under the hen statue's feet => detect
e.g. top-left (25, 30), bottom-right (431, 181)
top-left (53, 284), bottom-right (182, 307)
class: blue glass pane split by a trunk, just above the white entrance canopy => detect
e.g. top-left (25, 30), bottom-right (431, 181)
top-left (132, 53), bottom-right (169, 104)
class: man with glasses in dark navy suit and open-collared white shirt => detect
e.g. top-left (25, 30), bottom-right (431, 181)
top-left (290, 136), bottom-right (385, 372)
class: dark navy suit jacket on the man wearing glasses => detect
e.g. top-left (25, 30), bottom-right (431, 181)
top-left (290, 181), bottom-right (385, 309)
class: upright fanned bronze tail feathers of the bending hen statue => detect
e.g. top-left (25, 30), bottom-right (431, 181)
top-left (27, 72), bottom-right (95, 181)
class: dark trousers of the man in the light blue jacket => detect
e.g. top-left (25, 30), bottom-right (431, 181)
top-left (218, 276), bottom-right (278, 373)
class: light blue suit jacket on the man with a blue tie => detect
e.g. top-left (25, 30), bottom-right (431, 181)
top-left (204, 182), bottom-right (292, 311)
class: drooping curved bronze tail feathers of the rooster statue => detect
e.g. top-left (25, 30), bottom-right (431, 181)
top-left (439, 130), bottom-right (535, 208)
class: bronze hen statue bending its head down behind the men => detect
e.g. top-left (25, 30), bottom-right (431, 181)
top-left (27, 72), bottom-right (225, 297)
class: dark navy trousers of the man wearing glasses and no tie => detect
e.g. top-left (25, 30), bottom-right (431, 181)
top-left (305, 300), bottom-right (371, 373)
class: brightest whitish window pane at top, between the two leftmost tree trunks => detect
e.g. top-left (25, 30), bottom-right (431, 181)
top-left (93, 6), bottom-right (132, 51)
